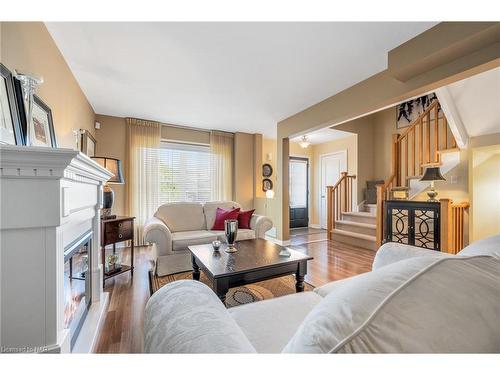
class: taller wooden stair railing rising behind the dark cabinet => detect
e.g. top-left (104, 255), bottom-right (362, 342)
top-left (376, 100), bottom-right (458, 250)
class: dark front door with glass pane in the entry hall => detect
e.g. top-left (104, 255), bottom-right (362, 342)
top-left (289, 157), bottom-right (309, 228)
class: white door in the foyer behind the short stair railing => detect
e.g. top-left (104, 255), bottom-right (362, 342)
top-left (319, 150), bottom-right (347, 229)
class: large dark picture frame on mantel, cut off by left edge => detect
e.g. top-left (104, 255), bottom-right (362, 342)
top-left (0, 63), bottom-right (25, 145)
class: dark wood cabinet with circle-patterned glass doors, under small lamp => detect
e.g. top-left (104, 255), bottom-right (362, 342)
top-left (385, 200), bottom-right (441, 251)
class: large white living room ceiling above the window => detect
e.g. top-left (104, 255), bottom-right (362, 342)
top-left (47, 22), bottom-right (436, 137)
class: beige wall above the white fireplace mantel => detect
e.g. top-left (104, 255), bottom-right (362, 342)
top-left (1, 22), bottom-right (95, 148)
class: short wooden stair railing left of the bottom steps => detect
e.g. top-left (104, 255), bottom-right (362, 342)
top-left (326, 172), bottom-right (356, 240)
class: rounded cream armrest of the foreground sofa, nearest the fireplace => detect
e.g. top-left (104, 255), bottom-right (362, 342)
top-left (144, 280), bottom-right (255, 353)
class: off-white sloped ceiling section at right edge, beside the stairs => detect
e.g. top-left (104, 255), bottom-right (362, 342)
top-left (447, 68), bottom-right (500, 137)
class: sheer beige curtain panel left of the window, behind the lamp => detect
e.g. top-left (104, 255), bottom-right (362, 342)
top-left (125, 118), bottom-right (161, 245)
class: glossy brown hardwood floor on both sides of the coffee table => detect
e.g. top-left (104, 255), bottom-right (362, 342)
top-left (96, 239), bottom-right (375, 353)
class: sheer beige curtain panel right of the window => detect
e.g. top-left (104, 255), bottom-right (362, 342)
top-left (210, 131), bottom-right (234, 200)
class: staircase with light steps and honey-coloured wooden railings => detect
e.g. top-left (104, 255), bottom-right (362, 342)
top-left (327, 100), bottom-right (463, 254)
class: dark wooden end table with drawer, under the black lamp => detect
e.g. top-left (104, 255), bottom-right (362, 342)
top-left (101, 216), bottom-right (135, 286)
